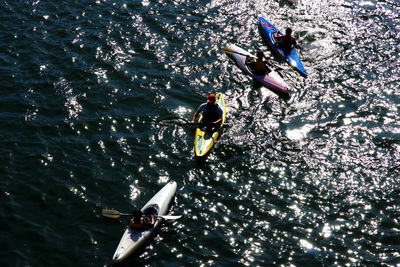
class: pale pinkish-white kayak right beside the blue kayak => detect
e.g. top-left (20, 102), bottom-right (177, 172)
top-left (222, 44), bottom-right (290, 93)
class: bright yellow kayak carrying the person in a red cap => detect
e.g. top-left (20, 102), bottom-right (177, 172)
top-left (194, 93), bottom-right (226, 158)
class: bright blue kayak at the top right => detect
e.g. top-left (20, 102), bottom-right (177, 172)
top-left (259, 17), bottom-right (308, 77)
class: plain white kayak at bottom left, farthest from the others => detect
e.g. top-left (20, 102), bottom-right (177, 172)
top-left (113, 181), bottom-right (176, 262)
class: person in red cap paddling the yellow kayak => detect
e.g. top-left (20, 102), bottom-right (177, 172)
top-left (192, 94), bottom-right (223, 132)
